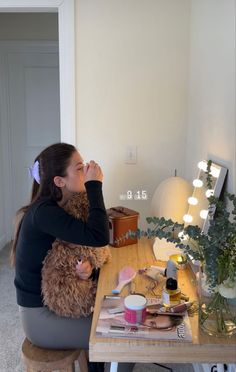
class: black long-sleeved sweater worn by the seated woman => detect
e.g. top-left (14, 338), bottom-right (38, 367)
top-left (14, 181), bottom-right (109, 307)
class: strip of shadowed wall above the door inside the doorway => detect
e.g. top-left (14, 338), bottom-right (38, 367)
top-left (0, 13), bottom-right (58, 40)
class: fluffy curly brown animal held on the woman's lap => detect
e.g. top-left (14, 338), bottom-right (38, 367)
top-left (42, 192), bottom-right (111, 318)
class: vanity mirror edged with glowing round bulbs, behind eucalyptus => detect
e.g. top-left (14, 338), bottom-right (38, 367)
top-left (183, 160), bottom-right (227, 233)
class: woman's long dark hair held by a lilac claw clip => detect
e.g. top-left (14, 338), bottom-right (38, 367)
top-left (10, 143), bottom-right (76, 266)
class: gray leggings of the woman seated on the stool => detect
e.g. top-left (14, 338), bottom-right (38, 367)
top-left (19, 306), bottom-right (92, 350)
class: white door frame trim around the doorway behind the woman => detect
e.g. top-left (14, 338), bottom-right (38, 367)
top-left (0, 0), bottom-right (76, 145)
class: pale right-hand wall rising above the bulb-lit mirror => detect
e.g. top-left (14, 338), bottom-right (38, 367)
top-left (186, 0), bottom-right (236, 193)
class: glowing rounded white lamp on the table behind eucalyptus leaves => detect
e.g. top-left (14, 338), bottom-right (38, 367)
top-left (151, 177), bottom-right (193, 261)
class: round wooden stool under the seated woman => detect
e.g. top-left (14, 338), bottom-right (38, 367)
top-left (22, 338), bottom-right (88, 372)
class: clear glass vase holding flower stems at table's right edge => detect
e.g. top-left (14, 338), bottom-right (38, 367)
top-left (199, 273), bottom-right (236, 337)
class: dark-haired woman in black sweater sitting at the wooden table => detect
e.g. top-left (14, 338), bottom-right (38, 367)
top-left (11, 143), bottom-right (109, 370)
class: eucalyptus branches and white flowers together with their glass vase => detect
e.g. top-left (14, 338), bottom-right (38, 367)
top-left (117, 161), bottom-right (236, 336)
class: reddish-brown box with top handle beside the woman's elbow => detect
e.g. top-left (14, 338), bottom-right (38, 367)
top-left (107, 206), bottom-right (139, 247)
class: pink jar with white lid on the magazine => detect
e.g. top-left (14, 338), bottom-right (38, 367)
top-left (124, 294), bottom-right (147, 324)
